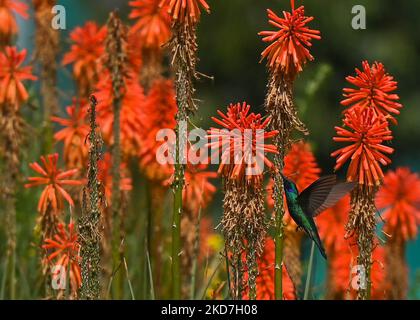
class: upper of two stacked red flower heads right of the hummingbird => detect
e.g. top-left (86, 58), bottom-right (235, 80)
top-left (341, 61), bottom-right (402, 122)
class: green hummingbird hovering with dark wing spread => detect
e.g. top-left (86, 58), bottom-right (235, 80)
top-left (282, 174), bottom-right (356, 259)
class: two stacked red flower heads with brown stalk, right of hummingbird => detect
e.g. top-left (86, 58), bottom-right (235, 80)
top-left (331, 61), bottom-right (402, 300)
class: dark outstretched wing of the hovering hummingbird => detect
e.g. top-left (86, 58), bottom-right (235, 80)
top-left (298, 175), bottom-right (355, 217)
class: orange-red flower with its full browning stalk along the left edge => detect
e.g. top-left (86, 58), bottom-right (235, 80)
top-left (0, 46), bottom-right (36, 299)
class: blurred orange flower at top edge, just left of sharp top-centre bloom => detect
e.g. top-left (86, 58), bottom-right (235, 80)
top-left (129, 0), bottom-right (171, 49)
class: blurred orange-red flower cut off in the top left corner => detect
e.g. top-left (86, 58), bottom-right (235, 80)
top-left (0, 0), bottom-right (28, 43)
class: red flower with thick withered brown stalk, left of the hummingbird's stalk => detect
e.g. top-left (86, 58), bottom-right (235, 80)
top-left (208, 102), bottom-right (278, 300)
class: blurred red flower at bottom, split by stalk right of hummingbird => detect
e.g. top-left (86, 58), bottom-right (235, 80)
top-left (330, 241), bottom-right (385, 299)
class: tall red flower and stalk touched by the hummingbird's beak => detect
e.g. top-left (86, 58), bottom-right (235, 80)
top-left (259, 0), bottom-right (321, 300)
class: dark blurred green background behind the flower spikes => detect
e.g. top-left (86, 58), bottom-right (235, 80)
top-left (12, 0), bottom-right (420, 299)
